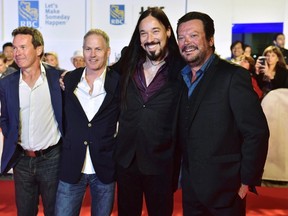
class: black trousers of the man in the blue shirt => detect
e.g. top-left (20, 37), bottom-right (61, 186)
top-left (181, 167), bottom-right (246, 216)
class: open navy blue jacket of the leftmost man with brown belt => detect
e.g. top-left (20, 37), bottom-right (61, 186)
top-left (0, 64), bottom-right (62, 173)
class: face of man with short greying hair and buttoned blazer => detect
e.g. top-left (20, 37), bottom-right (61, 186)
top-left (83, 34), bottom-right (110, 71)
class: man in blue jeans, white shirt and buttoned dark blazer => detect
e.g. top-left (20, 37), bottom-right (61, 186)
top-left (55, 29), bottom-right (120, 216)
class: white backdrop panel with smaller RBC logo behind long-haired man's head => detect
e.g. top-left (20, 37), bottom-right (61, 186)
top-left (90, 0), bottom-right (186, 62)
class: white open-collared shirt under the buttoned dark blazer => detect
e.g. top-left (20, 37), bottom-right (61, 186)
top-left (74, 69), bottom-right (106, 174)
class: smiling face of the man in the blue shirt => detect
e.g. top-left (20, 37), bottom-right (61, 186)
top-left (178, 19), bottom-right (214, 68)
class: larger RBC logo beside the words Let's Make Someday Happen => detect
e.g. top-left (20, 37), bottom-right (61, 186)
top-left (18, 0), bottom-right (39, 28)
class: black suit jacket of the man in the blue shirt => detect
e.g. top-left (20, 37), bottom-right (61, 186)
top-left (179, 56), bottom-right (269, 207)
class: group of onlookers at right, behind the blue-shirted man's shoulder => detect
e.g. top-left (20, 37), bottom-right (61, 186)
top-left (227, 33), bottom-right (288, 99)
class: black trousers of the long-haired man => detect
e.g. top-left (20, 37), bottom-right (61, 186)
top-left (117, 160), bottom-right (173, 216)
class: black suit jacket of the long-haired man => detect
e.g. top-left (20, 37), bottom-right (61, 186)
top-left (115, 54), bottom-right (183, 175)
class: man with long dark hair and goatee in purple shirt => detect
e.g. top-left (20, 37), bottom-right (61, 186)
top-left (113, 8), bottom-right (184, 216)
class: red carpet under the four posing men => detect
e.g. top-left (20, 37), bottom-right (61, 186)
top-left (0, 180), bottom-right (288, 216)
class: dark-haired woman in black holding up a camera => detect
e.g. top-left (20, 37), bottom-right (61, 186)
top-left (255, 46), bottom-right (288, 96)
